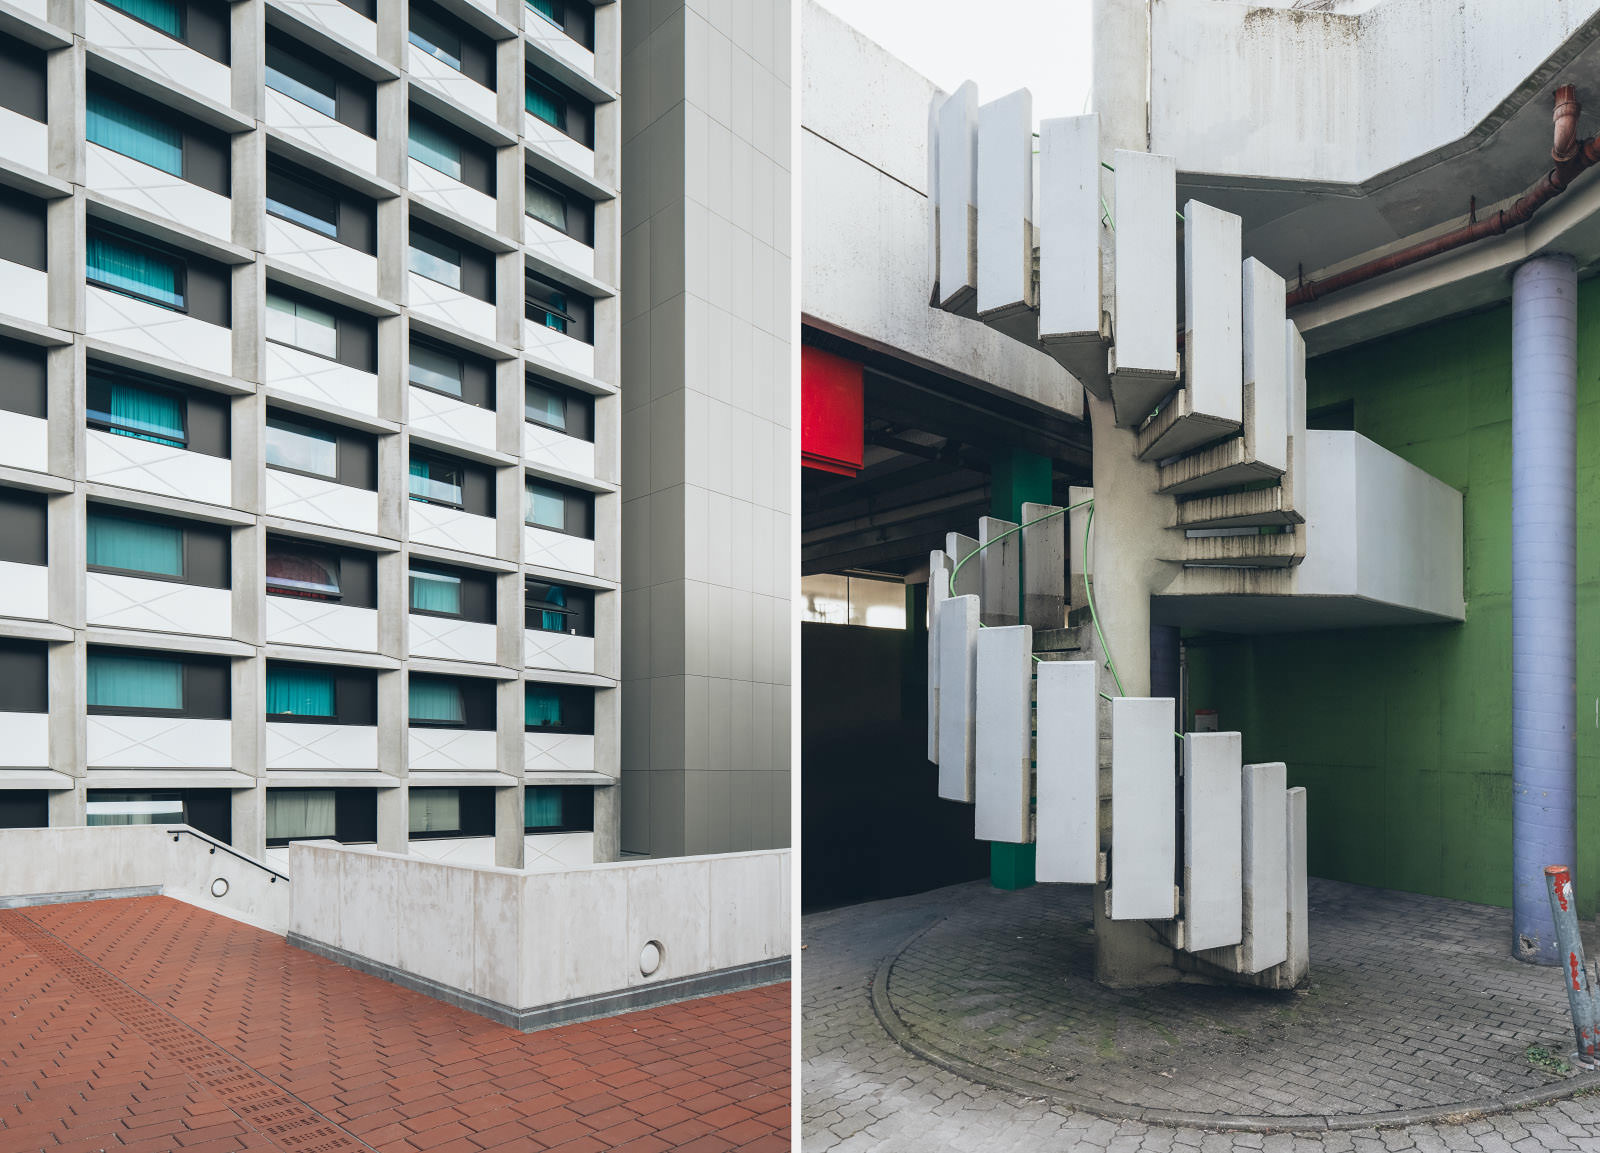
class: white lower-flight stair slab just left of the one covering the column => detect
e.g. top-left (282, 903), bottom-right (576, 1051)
top-left (1034, 660), bottom-right (1099, 884)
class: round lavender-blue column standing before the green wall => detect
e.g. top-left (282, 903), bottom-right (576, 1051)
top-left (1510, 256), bottom-right (1578, 964)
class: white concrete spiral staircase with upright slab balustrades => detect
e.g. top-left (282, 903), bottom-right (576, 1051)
top-left (928, 83), bottom-right (1309, 988)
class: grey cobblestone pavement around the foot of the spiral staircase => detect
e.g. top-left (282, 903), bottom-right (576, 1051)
top-left (802, 883), bottom-right (1600, 1153)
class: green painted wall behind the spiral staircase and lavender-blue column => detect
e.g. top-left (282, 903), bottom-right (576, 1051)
top-left (1189, 281), bottom-right (1600, 916)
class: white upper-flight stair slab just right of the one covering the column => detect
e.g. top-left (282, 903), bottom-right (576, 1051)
top-left (1184, 200), bottom-right (1245, 424)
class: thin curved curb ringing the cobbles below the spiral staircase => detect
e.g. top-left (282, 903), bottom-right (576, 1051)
top-left (869, 916), bottom-right (1600, 1132)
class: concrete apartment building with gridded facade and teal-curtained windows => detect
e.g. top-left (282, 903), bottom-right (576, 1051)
top-left (0, 0), bottom-right (787, 867)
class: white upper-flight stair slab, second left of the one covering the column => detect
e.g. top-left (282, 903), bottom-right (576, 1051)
top-left (978, 88), bottom-right (1034, 318)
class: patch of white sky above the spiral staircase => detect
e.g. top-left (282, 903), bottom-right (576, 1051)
top-left (818, 0), bottom-right (1091, 123)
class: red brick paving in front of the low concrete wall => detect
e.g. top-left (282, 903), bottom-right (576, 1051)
top-left (0, 897), bottom-right (790, 1153)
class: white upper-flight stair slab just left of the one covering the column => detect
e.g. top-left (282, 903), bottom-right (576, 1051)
top-left (1037, 117), bottom-right (1101, 344)
